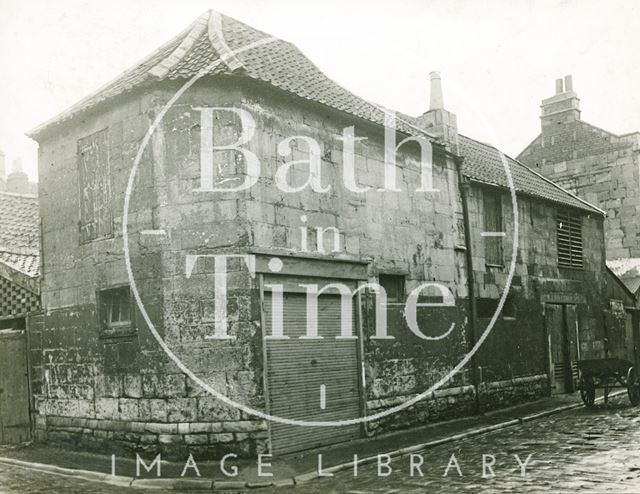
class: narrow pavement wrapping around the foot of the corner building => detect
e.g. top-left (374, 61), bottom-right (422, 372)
top-left (0, 395), bottom-right (628, 492)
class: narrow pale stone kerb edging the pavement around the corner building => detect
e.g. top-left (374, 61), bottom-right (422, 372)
top-left (0, 391), bottom-right (626, 491)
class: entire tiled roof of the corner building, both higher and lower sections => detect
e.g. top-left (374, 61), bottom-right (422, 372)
top-left (31, 11), bottom-right (600, 213)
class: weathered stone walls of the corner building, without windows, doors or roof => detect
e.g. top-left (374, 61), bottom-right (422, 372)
top-left (32, 79), bottom-right (632, 457)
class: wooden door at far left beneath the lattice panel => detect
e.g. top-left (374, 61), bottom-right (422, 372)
top-left (0, 329), bottom-right (31, 444)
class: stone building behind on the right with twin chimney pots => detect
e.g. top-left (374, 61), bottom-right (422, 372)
top-left (518, 76), bottom-right (640, 295)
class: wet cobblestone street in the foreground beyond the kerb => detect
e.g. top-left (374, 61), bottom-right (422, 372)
top-left (0, 396), bottom-right (640, 494)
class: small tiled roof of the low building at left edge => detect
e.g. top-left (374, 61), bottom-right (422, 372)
top-left (0, 192), bottom-right (40, 277)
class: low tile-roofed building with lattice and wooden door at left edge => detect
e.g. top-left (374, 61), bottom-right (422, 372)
top-left (0, 192), bottom-right (40, 444)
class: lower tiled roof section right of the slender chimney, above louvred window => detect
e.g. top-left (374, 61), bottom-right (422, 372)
top-left (459, 135), bottom-right (604, 214)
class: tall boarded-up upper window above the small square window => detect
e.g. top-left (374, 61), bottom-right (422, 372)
top-left (78, 129), bottom-right (113, 242)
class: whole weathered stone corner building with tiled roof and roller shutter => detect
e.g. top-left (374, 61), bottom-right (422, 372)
top-left (31, 11), bottom-right (637, 457)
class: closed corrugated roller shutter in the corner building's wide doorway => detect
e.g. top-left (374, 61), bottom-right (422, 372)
top-left (264, 292), bottom-right (360, 454)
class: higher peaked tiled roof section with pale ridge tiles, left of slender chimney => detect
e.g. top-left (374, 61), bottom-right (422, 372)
top-left (30, 11), bottom-right (433, 141)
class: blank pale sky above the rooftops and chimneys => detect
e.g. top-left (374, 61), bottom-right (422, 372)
top-left (0, 0), bottom-right (640, 180)
